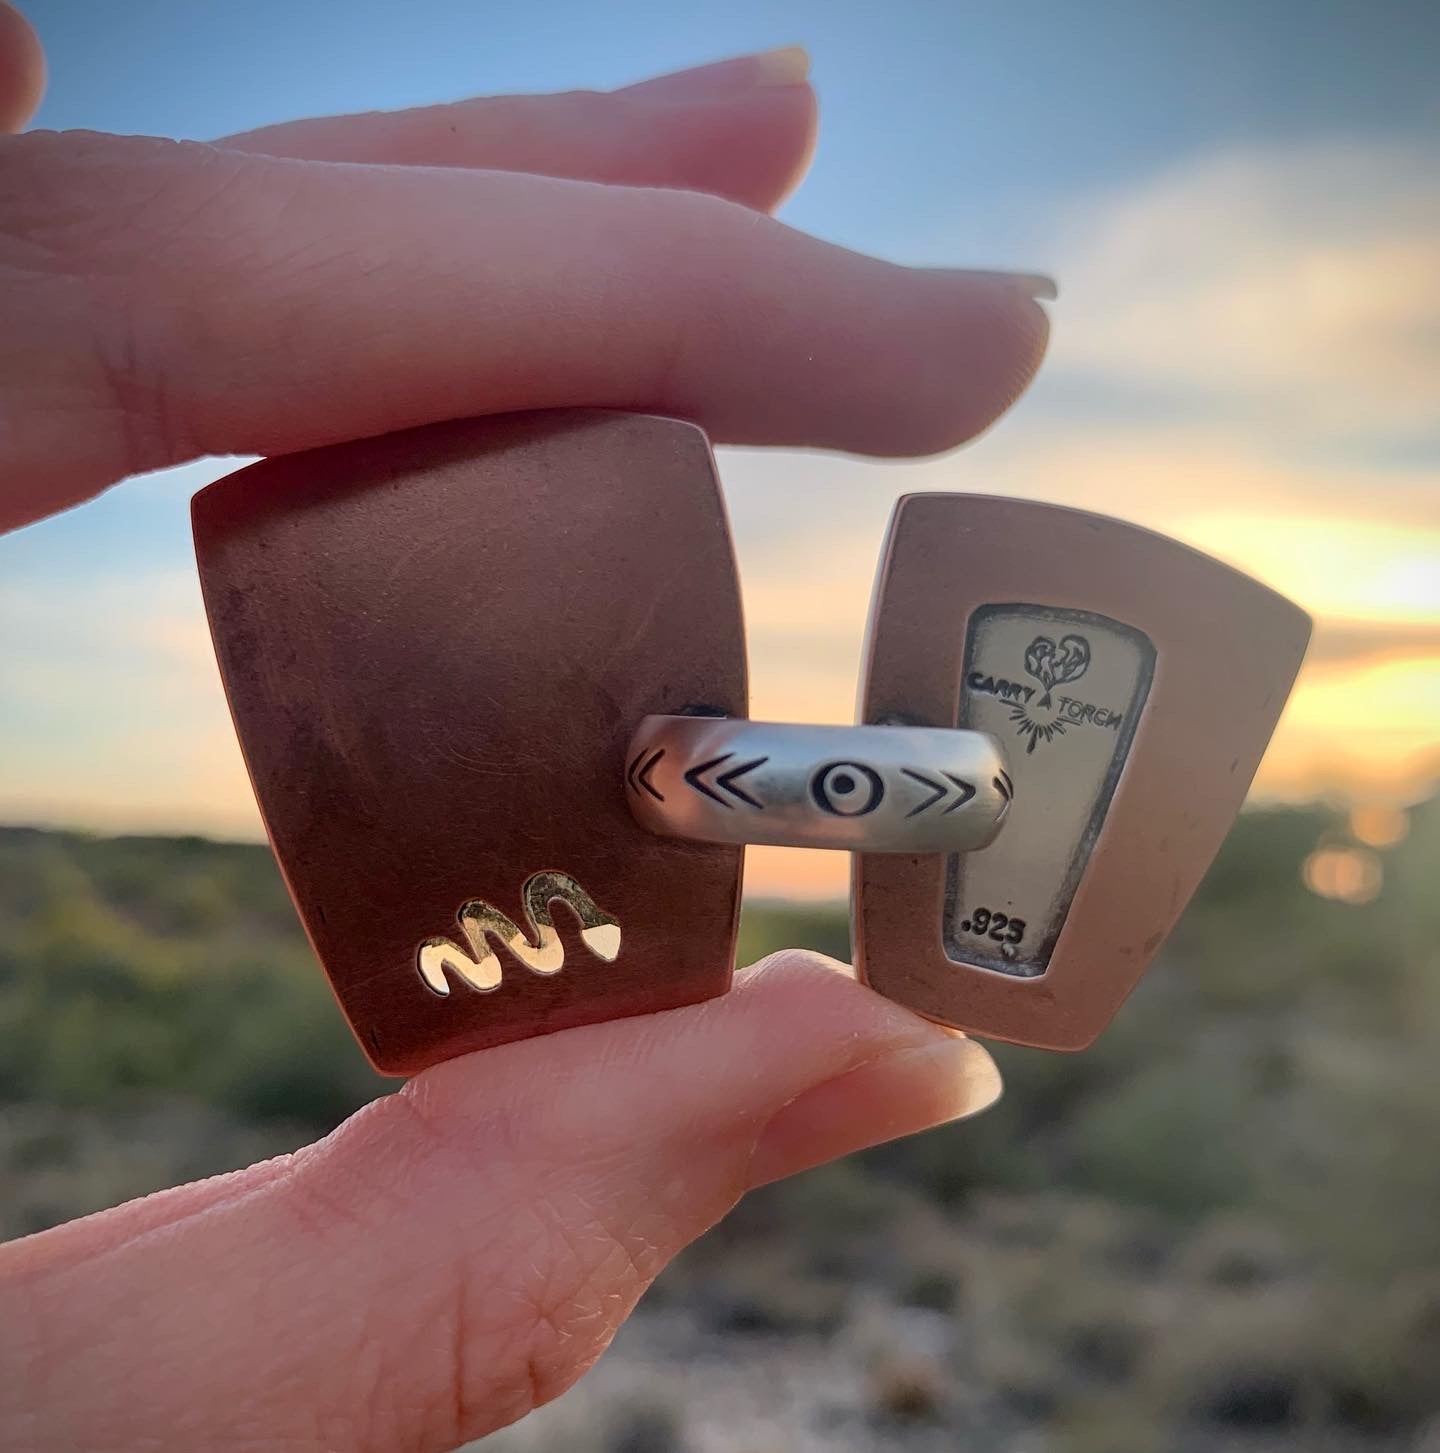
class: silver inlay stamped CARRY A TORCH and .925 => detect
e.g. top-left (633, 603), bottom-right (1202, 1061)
top-left (943, 604), bottom-right (1155, 978)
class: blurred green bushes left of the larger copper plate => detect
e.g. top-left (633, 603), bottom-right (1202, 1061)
top-left (0, 828), bottom-right (385, 1129)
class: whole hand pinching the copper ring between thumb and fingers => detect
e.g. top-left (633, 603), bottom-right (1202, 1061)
top-left (0, 4), bottom-right (1046, 1453)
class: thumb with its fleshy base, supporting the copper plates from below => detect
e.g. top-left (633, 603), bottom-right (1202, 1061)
top-left (0, 953), bottom-right (1000, 1453)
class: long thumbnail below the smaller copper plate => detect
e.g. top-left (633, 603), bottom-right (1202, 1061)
top-left (750, 1035), bottom-right (1003, 1186)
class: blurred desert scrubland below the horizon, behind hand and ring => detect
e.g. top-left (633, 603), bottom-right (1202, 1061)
top-left (0, 801), bottom-right (1440, 1453)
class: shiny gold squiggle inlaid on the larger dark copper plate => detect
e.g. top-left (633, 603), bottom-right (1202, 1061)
top-left (416, 872), bottom-right (620, 997)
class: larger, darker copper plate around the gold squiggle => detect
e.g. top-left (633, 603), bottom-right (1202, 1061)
top-left (193, 410), bottom-right (745, 1074)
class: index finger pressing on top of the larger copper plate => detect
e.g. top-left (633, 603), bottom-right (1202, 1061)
top-left (0, 134), bottom-right (1046, 525)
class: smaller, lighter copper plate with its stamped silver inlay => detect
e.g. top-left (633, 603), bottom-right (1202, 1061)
top-left (853, 494), bottom-right (1309, 1049)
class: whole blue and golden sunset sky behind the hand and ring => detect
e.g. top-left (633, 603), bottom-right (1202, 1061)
top-left (0, 0), bottom-right (1440, 895)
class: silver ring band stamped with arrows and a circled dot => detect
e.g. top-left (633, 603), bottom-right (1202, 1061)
top-left (625, 716), bottom-right (1014, 853)
